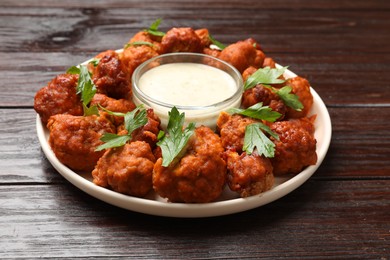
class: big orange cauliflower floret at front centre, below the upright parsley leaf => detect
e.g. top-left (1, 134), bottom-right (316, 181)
top-left (153, 126), bottom-right (226, 203)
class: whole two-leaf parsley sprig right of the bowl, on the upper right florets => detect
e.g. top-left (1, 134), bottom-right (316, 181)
top-left (244, 67), bottom-right (303, 111)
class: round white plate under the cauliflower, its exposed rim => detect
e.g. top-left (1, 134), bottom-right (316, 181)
top-left (36, 67), bottom-right (332, 218)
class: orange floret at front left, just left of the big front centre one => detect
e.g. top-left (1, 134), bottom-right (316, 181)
top-left (92, 141), bottom-right (156, 197)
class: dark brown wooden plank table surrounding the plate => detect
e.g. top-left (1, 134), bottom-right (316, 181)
top-left (0, 0), bottom-right (390, 259)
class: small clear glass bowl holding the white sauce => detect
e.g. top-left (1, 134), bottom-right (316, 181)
top-left (132, 52), bottom-right (243, 130)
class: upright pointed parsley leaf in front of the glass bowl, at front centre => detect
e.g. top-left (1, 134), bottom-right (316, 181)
top-left (157, 107), bottom-right (195, 167)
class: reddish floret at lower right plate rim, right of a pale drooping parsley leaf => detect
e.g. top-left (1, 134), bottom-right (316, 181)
top-left (270, 117), bottom-right (317, 175)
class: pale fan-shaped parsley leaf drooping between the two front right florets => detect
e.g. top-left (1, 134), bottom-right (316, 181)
top-left (242, 123), bottom-right (279, 157)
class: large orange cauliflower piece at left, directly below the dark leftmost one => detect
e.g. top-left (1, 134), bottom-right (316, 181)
top-left (47, 114), bottom-right (115, 171)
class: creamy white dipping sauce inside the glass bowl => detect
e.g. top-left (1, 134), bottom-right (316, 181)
top-left (138, 63), bottom-right (237, 106)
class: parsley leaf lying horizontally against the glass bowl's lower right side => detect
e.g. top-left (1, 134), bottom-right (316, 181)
top-left (227, 102), bottom-right (282, 122)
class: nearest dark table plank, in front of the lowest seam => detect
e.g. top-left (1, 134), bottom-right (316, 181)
top-left (0, 180), bottom-right (390, 259)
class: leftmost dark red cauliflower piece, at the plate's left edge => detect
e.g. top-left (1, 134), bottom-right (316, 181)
top-left (34, 74), bottom-right (84, 125)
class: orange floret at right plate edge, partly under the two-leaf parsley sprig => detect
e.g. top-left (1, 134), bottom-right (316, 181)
top-left (286, 76), bottom-right (313, 118)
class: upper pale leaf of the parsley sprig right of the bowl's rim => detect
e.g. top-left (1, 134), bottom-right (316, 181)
top-left (244, 67), bottom-right (287, 90)
